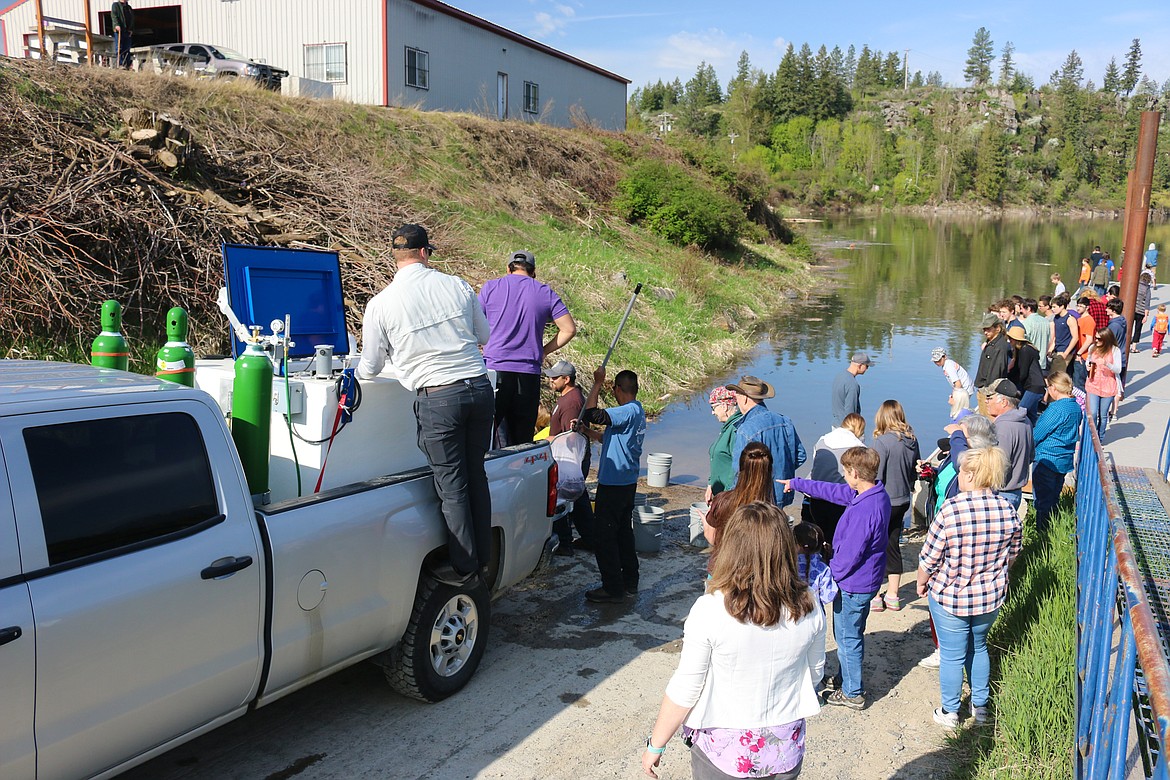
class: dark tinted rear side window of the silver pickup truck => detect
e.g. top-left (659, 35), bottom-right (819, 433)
top-left (25, 413), bottom-right (220, 565)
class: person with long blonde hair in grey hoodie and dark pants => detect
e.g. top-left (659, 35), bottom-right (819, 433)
top-left (869, 399), bottom-right (922, 612)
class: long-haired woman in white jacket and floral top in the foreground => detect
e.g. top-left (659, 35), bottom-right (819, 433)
top-left (642, 502), bottom-right (825, 780)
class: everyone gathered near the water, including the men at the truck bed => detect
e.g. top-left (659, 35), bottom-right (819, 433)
top-left (358, 225), bottom-right (1146, 778)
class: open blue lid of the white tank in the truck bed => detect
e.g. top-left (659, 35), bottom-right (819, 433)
top-left (223, 243), bottom-right (350, 358)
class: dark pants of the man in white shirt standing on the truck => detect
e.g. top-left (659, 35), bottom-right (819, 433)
top-left (414, 377), bottom-right (493, 574)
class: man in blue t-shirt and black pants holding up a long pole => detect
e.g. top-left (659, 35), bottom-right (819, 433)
top-left (574, 367), bottom-right (646, 603)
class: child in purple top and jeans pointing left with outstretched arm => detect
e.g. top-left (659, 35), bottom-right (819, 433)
top-left (777, 447), bottom-right (889, 710)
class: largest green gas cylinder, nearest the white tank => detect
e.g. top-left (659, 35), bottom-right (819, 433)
top-left (232, 327), bottom-right (273, 496)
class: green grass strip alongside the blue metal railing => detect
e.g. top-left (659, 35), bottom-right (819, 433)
top-left (950, 496), bottom-right (1076, 780)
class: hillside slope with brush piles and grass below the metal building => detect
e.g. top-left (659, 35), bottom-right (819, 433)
top-left (0, 60), bottom-right (808, 406)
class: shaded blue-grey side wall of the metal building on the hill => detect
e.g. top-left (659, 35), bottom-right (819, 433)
top-left (387, 0), bottom-right (626, 130)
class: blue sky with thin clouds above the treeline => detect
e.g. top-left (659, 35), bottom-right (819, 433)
top-left (447, 0), bottom-right (1170, 91)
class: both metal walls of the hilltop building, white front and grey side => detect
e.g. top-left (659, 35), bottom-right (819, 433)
top-left (0, 0), bottom-right (626, 130)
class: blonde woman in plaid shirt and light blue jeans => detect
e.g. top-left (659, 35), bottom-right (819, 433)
top-left (918, 447), bottom-right (1020, 729)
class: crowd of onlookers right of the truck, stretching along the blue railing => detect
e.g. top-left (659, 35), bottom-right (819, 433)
top-left (642, 244), bottom-right (1168, 778)
